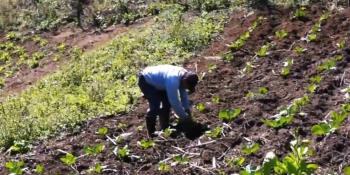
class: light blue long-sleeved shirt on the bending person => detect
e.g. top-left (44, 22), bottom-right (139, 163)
top-left (141, 65), bottom-right (190, 118)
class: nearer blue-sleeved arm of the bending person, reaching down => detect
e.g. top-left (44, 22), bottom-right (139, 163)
top-left (165, 77), bottom-right (188, 119)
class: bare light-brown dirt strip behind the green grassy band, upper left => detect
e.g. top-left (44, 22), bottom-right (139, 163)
top-left (1, 17), bottom-right (151, 97)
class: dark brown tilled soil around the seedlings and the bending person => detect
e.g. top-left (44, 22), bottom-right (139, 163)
top-left (0, 6), bottom-right (350, 174)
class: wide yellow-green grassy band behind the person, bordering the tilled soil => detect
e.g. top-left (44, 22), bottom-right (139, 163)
top-left (0, 5), bottom-right (229, 147)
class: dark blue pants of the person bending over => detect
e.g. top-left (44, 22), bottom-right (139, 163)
top-left (138, 75), bottom-right (171, 130)
